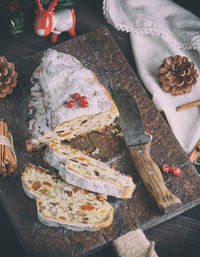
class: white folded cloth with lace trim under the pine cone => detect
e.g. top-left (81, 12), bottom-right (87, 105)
top-left (103, 0), bottom-right (200, 153)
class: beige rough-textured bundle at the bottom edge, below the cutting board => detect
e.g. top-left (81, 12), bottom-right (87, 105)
top-left (113, 229), bottom-right (158, 257)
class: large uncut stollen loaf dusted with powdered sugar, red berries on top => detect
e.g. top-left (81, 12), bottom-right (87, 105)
top-left (27, 49), bottom-right (119, 151)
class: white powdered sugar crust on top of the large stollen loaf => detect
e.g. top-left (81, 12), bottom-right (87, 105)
top-left (29, 49), bottom-right (114, 142)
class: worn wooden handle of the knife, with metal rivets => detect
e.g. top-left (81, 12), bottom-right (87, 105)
top-left (129, 141), bottom-right (182, 213)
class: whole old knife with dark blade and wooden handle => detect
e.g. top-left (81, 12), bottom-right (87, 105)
top-left (112, 89), bottom-right (182, 213)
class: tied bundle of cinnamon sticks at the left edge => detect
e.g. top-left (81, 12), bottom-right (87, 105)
top-left (0, 118), bottom-right (17, 177)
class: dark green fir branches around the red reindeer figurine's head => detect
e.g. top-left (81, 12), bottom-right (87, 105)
top-left (0, 0), bottom-right (75, 35)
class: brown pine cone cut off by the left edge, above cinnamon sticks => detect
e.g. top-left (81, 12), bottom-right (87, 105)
top-left (0, 56), bottom-right (18, 98)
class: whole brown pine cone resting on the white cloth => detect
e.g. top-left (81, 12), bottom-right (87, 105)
top-left (158, 55), bottom-right (198, 95)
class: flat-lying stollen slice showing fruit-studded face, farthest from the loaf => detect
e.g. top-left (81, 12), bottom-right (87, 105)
top-left (22, 164), bottom-right (114, 231)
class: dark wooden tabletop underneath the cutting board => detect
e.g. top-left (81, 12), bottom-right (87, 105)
top-left (0, 0), bottom-right (200, 257)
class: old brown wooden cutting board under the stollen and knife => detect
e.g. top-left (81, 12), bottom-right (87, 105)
top-left (0, 28), bottom-right (200, 257)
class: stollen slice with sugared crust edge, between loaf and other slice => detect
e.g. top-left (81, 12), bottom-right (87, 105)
top-left (45, 142), bottom-right (135, 198)
